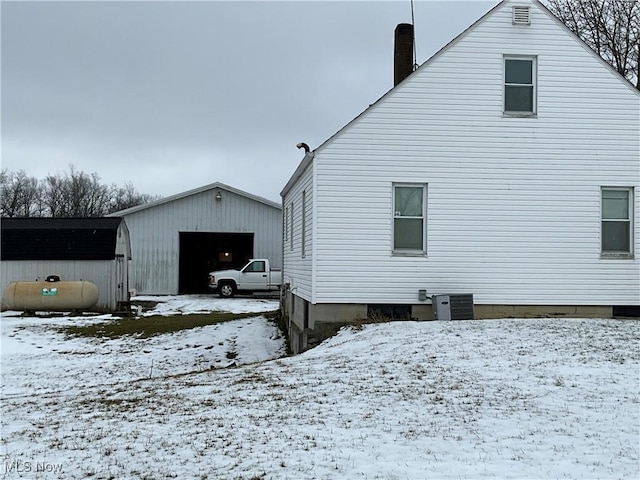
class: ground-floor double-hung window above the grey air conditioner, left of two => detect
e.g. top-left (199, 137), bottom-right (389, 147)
top-left (393, 183), bottom-right (427, 254)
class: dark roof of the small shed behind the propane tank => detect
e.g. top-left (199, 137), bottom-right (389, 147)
top-left (0, 217), bottom-right (122, 261)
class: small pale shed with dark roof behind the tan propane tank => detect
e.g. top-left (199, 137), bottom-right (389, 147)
top-left (0, 217), bottom-right (131, 312)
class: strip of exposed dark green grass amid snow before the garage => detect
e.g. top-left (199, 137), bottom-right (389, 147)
top-left (59, 312), bottom-right (268, 339)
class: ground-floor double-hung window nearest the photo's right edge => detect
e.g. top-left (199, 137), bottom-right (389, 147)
top-left (601, 187), bottom-right (633, 257)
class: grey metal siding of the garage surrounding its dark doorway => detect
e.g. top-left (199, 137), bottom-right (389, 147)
top-left (121, 187), bottom-right (282, 294)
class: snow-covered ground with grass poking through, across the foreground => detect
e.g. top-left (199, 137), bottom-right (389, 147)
top-left (0, 296), bottom-right (640, 480)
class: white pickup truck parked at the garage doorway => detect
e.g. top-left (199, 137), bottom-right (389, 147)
top-left (209, 258), bottom-right (282, 297)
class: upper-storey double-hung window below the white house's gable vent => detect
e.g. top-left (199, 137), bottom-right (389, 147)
top-left (504, 56), bottom-right (536, 116)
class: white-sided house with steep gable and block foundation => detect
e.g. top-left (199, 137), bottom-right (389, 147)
top-left (281, 0), bottom-right (640, 350)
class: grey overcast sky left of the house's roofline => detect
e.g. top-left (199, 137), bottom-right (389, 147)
top-left (1, 0), bottom-right (497, 202)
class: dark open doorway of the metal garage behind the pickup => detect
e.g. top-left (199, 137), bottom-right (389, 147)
top-left (178, 232), bottom-right (253, 293)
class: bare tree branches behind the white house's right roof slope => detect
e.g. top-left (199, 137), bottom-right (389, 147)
top-left (545, 0), bottom-right (640, 90)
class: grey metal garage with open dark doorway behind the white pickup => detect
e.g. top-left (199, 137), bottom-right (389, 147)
top-left (113, 183), bottom-right (282, 295)
